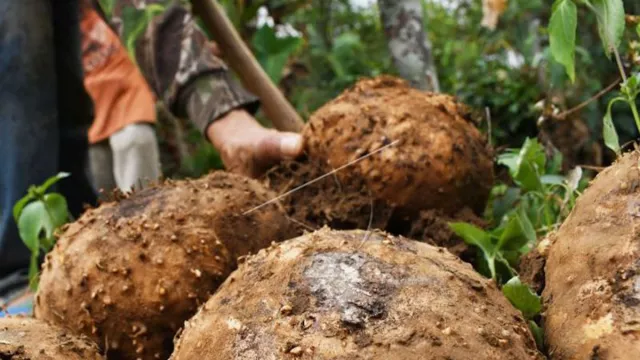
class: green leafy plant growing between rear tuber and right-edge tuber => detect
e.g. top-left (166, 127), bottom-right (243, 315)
top-left (450, 139), bottom-right (582, 284)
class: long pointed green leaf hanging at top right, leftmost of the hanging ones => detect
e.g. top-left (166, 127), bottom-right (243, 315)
top-left (549, 0), bottom-right (578, 82)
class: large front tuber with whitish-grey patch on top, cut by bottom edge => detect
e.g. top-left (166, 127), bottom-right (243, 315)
top-left (171, 229), bottom-right (541, 360)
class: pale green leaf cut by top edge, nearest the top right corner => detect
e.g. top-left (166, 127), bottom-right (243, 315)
top-left (591, 0), bottom-right (625, 55)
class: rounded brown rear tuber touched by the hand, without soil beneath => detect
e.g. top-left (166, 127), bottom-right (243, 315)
top-left (304, 76), bottom-right (493, 214)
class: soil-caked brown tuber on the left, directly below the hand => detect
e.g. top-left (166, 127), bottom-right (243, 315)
top-left (35, 172), bottom-right (294, 359)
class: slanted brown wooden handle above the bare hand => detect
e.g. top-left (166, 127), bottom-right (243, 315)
top-left (191, 0), bottom-right (304, 132)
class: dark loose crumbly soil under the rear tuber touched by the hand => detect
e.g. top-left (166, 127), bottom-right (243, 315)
top-left (266, 159), bottom-right (486, 260)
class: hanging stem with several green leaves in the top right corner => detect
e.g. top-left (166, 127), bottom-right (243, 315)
top-left (549, 0), bottom-right (640, 155)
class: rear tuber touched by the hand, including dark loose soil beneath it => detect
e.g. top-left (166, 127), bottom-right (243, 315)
top-left (265, 76), bottom-right (493, 253)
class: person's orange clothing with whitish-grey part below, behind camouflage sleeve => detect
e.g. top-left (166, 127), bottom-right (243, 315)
top-left (80, 3), bottom-right (161, 192)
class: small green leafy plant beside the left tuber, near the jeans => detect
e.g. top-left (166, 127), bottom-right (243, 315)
top-left (13, 173), bottom-right (71, 290)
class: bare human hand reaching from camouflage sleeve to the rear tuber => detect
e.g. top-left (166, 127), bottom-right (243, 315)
top-left (207, 110), bottom-right (304, 177)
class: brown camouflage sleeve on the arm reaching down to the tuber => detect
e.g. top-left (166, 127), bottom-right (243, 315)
top-left (111, 0), bottom-right (259, 132)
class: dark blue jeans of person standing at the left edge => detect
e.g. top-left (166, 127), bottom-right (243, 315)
top-left (0, 0), bottom-right (96, 297)
